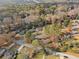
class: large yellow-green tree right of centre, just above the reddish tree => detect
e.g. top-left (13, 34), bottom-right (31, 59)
top-left (43, 24), bottom-right (61, 36)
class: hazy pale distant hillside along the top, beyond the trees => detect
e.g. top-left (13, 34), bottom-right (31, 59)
top-left (0, 0), bottom-right (79, 5)
